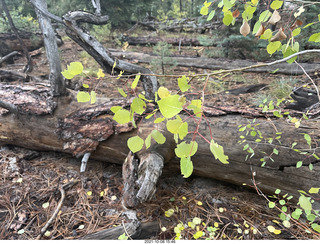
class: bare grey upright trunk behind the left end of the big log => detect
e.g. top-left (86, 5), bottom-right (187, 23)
top-left (30, 0), bottom-right (66, 96)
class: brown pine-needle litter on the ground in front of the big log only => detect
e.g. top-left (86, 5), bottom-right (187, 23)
top-left (0, 145), bottom-right (318, 240)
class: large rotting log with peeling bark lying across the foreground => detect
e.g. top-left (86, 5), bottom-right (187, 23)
top-left (0, 82), bottom-right (320, 207)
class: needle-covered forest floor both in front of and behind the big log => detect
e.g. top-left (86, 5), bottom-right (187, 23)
top-left (0, 29), bottom-right (319, 240)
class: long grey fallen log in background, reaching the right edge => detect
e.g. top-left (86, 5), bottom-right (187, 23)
top-left (111, 50), bottom-right (319, 75)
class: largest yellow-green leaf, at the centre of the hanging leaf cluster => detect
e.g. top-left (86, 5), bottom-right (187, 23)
top-left (157, 95), bottom-right (182, 119)
